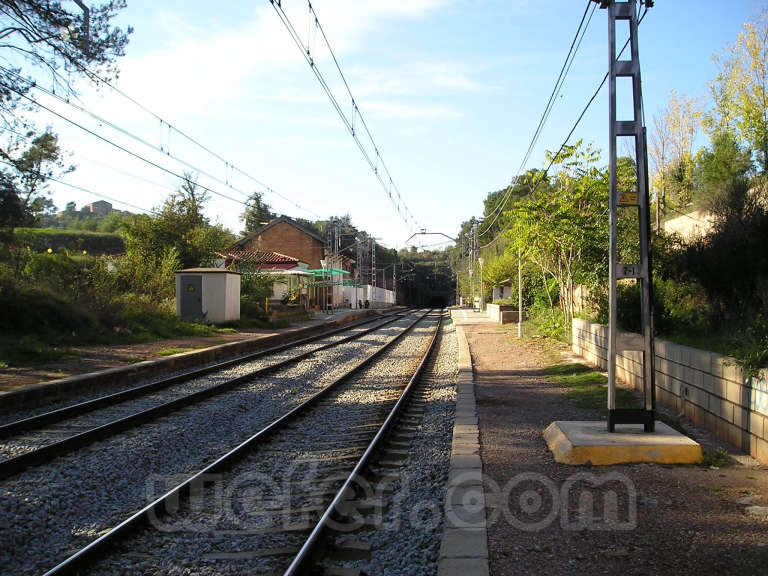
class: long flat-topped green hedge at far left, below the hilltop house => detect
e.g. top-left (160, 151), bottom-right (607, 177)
top-left (13, 228), bottom-right (125, 256)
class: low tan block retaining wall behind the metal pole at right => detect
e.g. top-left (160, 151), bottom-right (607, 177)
top-left (571, 318), bottom-right (768, 462)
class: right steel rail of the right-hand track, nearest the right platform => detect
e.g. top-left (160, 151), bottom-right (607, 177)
top-left (283, 314), bottom-right (443, 576)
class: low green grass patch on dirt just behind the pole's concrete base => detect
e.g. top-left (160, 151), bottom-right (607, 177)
top-left (541, 363), bottom-right (637, 412)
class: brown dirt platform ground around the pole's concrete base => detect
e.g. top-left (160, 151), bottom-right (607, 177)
top-left (465, 324), bottom-right (768, 576)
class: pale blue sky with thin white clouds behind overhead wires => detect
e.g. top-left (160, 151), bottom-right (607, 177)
top-left (27, 0), bottom-right (765, 247)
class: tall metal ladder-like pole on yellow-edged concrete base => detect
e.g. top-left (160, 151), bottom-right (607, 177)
top-left (595, 0), bottom-right (656, 432)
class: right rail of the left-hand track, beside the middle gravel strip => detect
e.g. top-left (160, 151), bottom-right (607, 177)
top-left (0, 308), bottom-right (414, 480)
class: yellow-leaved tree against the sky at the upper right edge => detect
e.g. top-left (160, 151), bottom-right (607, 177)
top-left (707, 8), bottom-right (768, 173)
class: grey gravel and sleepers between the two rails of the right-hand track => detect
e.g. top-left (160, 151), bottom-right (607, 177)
top-left (80, 319), bottom-right (436, 575)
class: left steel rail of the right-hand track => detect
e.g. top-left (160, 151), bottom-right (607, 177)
top-left (43, 312), bottom-right (436, 576)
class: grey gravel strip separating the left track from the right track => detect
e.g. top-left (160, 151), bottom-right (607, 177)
top-left (0, 312), bottom-right (420, 574)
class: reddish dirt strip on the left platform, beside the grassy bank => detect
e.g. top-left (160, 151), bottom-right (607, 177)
top-left (0, 328), bottom-right (282, 391)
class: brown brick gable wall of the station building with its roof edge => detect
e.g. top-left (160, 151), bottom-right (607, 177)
top-left (230, 216), bottom-right (326, 269)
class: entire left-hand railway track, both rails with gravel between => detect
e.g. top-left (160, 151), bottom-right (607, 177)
top-left (0, 314), bottom-right (403, 480)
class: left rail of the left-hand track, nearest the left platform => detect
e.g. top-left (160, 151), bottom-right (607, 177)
top-left (0, 313), bottom-right (399, 438)
